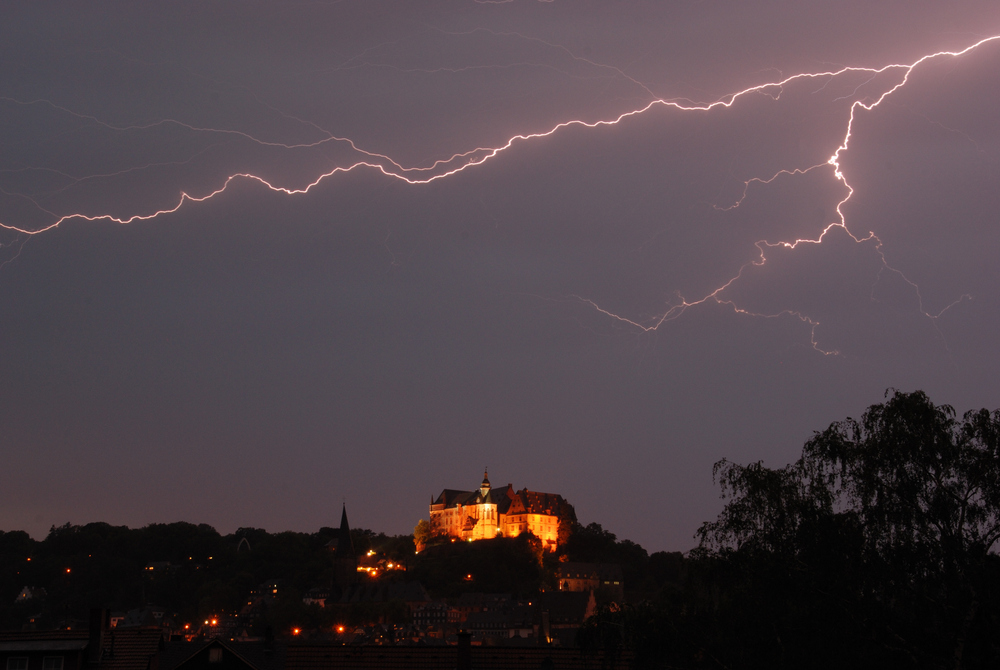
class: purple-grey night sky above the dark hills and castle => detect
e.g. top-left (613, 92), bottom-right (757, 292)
top-left (0, 0), bottom-right (1000, 551)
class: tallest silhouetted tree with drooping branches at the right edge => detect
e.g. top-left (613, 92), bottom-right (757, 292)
top-left (803, 391), bottom-right (1000, 668)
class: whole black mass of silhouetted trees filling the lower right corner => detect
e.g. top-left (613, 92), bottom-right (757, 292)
top-left (580, 392), bottom-right (1000, 670)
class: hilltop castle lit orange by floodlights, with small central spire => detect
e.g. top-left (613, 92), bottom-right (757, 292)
top-left (430, 472), bottom-right (576, 551)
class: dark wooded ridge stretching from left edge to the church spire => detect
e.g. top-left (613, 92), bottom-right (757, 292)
top-left (0, 523), bottom-right (413, 629)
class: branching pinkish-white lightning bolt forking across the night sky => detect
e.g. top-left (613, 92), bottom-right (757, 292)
top-left (0, 34), bottom-right (1000, 355)
